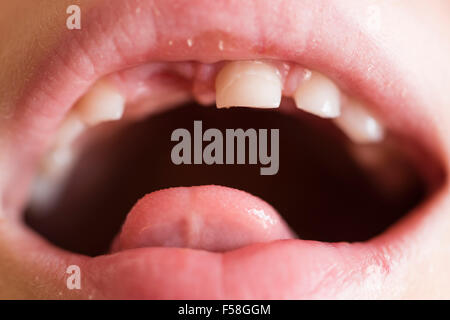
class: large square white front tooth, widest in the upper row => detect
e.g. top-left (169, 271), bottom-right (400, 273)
top-left (216, 61), bottom-right (282, 108)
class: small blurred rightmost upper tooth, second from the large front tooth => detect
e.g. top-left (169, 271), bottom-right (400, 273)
top-left (334, 100), bottom-right (384, 144)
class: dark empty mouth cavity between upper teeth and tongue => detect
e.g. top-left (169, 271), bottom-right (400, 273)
top-left (25, 104), bottom-right (426, 256)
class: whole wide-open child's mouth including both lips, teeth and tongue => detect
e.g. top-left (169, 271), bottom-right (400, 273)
top-left (2, 1), bottom-right (446, 298)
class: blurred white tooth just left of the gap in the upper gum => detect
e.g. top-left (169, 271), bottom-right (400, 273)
top-left (75, 81), bottom-right (125, 126)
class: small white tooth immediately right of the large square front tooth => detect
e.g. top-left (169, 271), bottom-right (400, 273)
top-left (294, 72), bottom-right (341, 118)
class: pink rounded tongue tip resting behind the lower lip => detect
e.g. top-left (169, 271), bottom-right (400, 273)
top-left (112, 186), bottom-right (294, 251)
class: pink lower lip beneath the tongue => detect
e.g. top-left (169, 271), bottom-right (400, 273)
top-left (85, 240), bottom-right (389, 299)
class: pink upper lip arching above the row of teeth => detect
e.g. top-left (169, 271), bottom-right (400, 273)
top-left (2, 0), bottom-right (443, 296)
